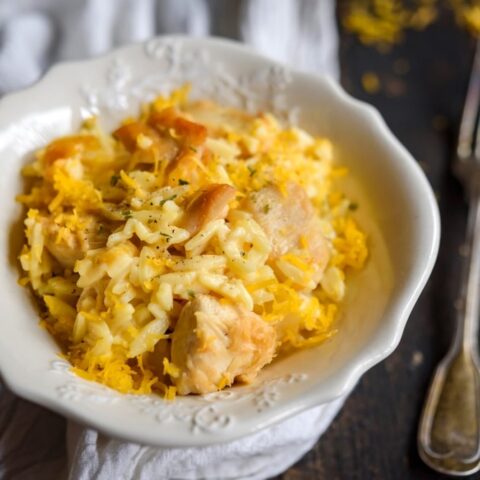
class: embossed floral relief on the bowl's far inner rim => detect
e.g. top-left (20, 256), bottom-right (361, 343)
top-left (80, 38), bottom-right (298, 123)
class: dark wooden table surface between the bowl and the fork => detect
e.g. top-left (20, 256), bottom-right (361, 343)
top-left (278, 7), bottom-right (480, 480)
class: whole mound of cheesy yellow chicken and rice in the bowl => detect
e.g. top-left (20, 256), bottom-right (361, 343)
top-left (18, 87), bottom-right (367, 399)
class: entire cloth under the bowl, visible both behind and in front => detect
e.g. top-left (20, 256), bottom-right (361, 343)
top-left (0, 0), bottom-right (344, 480)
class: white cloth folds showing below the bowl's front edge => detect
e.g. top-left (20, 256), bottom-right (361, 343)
top-left (68, 398), bottom-right (344, 480)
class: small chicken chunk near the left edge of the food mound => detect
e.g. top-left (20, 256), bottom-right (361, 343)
top-left (41, 218), bottom-right (109, 268)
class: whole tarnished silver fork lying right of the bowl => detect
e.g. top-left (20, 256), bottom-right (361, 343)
top-left (418, 40), bottom-right (480, 476)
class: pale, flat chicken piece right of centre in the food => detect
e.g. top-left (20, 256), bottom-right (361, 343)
top-left (246, 182), bottom-right (330, 278)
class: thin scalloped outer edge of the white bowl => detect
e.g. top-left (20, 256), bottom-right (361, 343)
top-left (0, 36), bottom-right (440, 446)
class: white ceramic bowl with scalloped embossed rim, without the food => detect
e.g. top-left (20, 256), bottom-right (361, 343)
top-left (0, 37), bottom-right (439, 446)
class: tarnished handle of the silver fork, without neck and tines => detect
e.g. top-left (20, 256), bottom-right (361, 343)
top-left (418, 192), bottom-right (480, 475)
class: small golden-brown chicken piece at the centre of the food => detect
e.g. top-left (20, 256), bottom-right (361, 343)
top-left (182, 183), bottom-right (236, 236)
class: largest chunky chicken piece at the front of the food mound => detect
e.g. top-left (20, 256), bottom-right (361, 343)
top-left (171, 295), bottom-right (276, 395)
